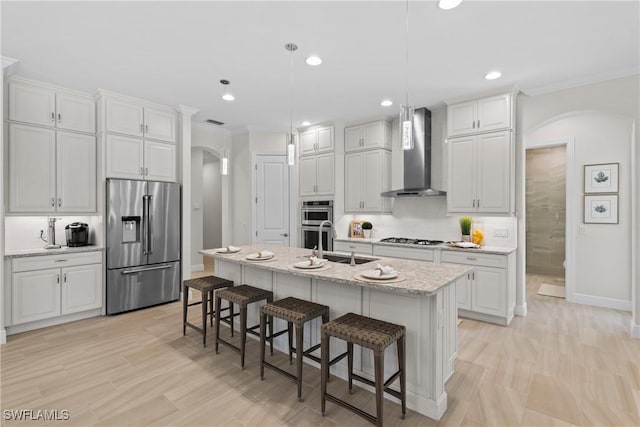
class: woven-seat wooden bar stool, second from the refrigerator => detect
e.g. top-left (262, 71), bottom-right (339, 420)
top-left (215, 285), bottom-right (273, 369)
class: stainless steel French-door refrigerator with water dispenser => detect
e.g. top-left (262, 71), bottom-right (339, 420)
top-left (106, 179), bottom-right (180, 314)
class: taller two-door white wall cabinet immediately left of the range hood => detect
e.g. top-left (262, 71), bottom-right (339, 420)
top-left (344, 150), bottom-right (391, 213)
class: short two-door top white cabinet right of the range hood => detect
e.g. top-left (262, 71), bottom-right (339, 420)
top-left (447, 93), bottom-right (512, 137)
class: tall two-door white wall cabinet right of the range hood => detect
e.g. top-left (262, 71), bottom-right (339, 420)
top-left (447, 131), bottom-right (514, 214)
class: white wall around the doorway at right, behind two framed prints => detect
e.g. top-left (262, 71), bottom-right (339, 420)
top-left (518, 76), bottom-right (640, 314)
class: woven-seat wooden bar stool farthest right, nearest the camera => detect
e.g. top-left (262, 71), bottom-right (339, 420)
top-left (321, 313), bottom-right (407, 426)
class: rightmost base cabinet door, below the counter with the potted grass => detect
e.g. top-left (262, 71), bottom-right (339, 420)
top-left (471, 267), bottom-right (507, 317)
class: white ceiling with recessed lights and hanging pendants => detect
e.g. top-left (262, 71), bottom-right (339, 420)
top-left (1, 0), bottom-right (640, 131)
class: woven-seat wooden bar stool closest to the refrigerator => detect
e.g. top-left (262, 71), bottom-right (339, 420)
top-left (182, 276), bottom-right (233, 347)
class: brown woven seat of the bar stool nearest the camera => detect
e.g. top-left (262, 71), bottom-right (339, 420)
top-left (322, 313), bottom-right (406, 351)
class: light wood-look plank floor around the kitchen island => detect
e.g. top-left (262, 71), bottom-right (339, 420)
top-left (0, 277), bottom-right (640, 427)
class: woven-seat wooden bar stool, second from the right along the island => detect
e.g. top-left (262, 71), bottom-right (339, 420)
top-left (260, 297), bottom-right (329, 402)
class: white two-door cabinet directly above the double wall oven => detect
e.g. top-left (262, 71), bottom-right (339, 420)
top-left (300, 153), bottom-right (335, 196)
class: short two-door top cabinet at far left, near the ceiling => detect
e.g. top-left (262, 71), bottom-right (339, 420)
top-left (9, 77), bottom-right (96, 133)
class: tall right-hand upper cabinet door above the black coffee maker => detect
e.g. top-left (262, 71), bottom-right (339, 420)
top-left (56, 131), bottom-right (97, 212)
